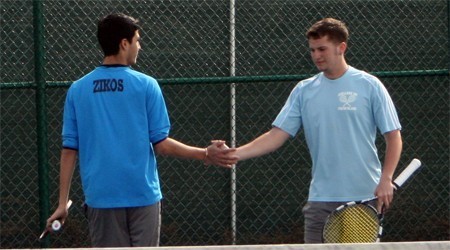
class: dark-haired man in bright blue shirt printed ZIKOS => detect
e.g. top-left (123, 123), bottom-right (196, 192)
top-left (47, 14), bottom-right (236, 247)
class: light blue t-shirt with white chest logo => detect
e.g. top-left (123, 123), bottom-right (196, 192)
top-left (272, 67), bottom-right (401, 201)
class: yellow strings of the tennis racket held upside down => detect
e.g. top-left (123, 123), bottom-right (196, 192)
top-left (323, 204), bottom-right (379, 243)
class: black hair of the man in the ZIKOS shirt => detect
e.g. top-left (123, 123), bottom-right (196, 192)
top-left (97, 13), bottom-right (140, 56)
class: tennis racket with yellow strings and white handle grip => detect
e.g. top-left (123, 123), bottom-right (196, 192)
top-left (322, 159), bottom-right (422, 243)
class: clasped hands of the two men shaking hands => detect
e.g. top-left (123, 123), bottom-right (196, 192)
top-left (203, 140), bottom-right (239, 168)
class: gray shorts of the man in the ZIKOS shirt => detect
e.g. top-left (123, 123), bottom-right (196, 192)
top-left (86, 202), bottom-right (161, 247)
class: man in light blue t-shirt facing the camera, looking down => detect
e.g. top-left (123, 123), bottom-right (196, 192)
top-left (230, 18), bottom-right (402, 243)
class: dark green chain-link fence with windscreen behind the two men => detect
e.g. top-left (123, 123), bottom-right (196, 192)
top-left (0, 0), bottom-right (450, 248)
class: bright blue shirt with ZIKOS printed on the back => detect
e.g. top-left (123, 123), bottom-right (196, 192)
top-left (62, 66), bottom-right (170, 208)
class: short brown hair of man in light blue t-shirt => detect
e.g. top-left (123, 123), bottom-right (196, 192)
top-left (306, 18), bottom-right (349, 43)
